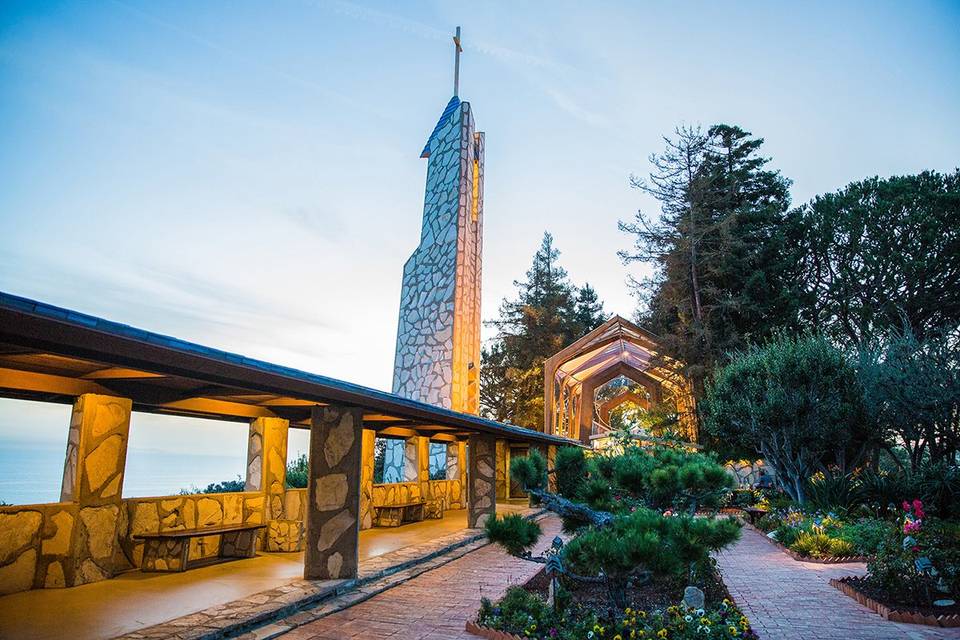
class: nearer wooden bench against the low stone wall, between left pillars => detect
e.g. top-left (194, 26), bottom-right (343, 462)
top-left (133, 524), bottom-right (266, 572)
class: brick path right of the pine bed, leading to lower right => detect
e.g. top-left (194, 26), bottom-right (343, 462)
top-left (717, 528), bottom-right (960, 640)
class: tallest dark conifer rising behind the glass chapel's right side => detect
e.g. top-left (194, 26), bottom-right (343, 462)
top-left (619, 125), bottom-right (800, 394)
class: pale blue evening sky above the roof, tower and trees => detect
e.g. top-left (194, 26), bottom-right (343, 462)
top-left (0, 0), bottom-right (960, 460)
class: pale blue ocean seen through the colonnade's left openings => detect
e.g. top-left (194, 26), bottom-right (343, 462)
top-left (0, 443), bottom-right (246, 504)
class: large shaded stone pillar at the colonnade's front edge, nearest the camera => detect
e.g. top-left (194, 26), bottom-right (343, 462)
top-left (303, 405), bottom-right (363, 580)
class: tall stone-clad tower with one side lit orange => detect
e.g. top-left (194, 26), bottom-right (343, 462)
top-left (393, 94), bottom-right (483, 414)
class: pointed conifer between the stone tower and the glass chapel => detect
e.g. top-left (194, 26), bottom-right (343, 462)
top-left (480, 233), bottom-right (606, 428)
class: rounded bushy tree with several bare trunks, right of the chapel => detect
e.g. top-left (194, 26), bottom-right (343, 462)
top-left (701, 334), bottom-right (877, 504)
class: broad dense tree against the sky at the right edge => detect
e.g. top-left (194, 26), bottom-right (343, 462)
top-left (790, 170), bottom-right (960, 344)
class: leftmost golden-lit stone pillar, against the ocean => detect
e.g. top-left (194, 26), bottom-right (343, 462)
top-left (60, 394), bottom-right (133, 586)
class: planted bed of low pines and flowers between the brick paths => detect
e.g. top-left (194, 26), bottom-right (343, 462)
top-left (478, 442), bottom-right (755, 640)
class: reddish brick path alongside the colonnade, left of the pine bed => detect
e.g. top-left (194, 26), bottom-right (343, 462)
top-left (270, 516), bottom-right (560, 640)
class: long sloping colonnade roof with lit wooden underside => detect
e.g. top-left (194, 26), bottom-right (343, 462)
top-left (0, 292), bottom-right (580, 446)
